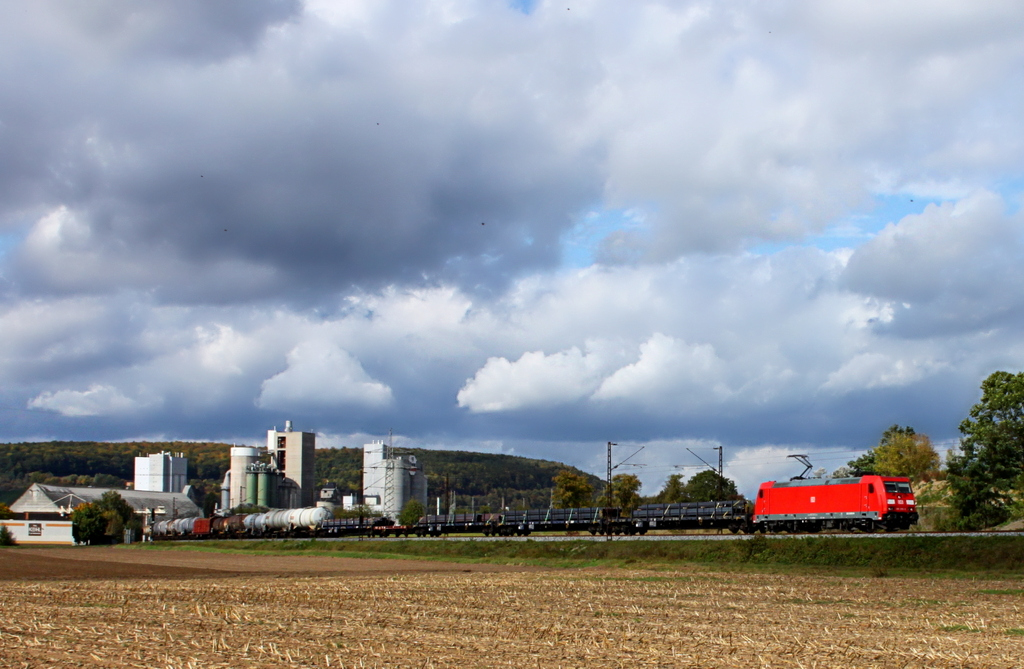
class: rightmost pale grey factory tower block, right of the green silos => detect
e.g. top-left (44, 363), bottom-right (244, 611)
top-left (362, 442), bottom-right (427, 518)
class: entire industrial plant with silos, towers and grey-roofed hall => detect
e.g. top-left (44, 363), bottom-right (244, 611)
top-left (3, 420), bottom-right (427, 544)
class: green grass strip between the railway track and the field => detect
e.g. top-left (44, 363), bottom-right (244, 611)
top-left (136, 535), bottom-right (1024, 576)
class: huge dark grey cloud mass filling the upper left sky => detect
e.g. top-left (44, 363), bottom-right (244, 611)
top-left (0, 4), bottom-right (600, 302)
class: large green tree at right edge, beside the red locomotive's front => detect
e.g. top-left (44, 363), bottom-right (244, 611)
top-left (947, 372), bottom-right (1024, 529)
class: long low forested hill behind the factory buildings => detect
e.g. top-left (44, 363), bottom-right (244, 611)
top-left (0, 442), bottom-right (597, 505)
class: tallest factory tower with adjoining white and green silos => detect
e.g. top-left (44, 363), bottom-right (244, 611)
top-left (221, 420), bottom-right (318, 509)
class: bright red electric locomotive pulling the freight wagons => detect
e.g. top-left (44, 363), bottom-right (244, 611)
top-left (752, 475), bottom-right (918, 533)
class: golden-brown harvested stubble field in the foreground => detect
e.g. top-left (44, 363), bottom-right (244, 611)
top-left (0, 551), bottom-right (1024, 669)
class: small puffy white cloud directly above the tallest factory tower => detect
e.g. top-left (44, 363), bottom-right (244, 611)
top-left (256, 341), bottom-right (394, 410)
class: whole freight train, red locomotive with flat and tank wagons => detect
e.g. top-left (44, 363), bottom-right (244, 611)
top-left (152, 475), bottom-right (918, 539)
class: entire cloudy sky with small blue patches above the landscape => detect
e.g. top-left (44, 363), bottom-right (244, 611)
top-left (0, 0), bottom-right (1024, 493)
